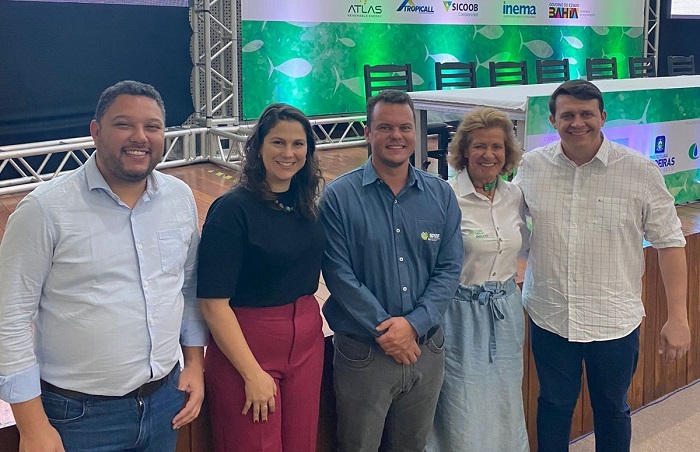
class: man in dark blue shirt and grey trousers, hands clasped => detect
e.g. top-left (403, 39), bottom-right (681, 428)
top-left (321, 90), bottom-right (462, 452)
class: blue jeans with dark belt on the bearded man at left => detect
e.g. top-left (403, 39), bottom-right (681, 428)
top-left (41, 369), bottom-right (185, 452)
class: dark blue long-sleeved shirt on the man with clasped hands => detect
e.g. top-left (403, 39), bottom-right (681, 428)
top-left (321, 160), bottom-right (462, 338)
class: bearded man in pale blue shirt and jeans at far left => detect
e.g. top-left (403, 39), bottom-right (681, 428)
top-left (0, 81), bottom-right (208, 451)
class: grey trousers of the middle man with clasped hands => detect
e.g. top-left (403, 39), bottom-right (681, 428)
top-left (333, 328), bottom-right (445, 452)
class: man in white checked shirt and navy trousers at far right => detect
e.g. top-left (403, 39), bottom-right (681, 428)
top-left (515, 80), bottom-right (690, 452)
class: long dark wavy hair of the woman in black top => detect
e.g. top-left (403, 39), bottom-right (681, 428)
top-left (241, 103), bottom-right (323, 220)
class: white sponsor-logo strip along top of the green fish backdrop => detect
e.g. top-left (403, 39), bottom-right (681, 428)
top-left (241, 0), bottom-right (644, 27)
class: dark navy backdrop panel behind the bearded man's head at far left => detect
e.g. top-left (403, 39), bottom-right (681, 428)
top-left (0, 0), bottom-right (194, 145)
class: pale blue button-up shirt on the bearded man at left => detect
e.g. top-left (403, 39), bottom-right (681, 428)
top-left (0, 155), bottom-right (208, 403)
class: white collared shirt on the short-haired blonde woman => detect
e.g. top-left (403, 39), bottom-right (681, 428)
top-left (449, 170), bottom-right (530, 286)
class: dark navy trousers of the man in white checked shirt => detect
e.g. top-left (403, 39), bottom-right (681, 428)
top-left (530, 321), bottom-right (639, 452)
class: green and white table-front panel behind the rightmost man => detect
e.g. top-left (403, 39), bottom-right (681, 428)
top-left (525, 87), bottom-right (700, 204)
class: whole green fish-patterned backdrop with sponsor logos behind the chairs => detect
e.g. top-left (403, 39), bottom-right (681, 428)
top-left (240, 0), bottom-right (645, 119)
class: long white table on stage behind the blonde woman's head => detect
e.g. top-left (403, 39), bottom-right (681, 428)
top-left (408, 75), bottom-right (700, 167)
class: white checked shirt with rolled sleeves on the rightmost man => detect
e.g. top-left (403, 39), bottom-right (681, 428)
top-left (515, 139), bottom-right (685, 342)
